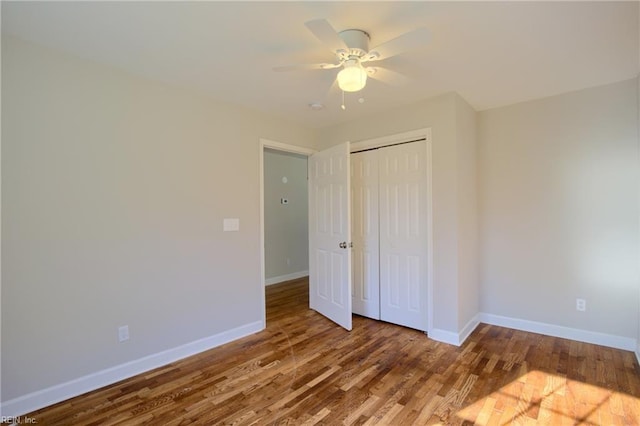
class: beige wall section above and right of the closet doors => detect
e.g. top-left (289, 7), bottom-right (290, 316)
top-left (318, 93), bottom-right (478, 340)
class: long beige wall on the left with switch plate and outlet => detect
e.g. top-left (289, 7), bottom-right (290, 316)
top-left (2, 36), bottom-right (314, 401)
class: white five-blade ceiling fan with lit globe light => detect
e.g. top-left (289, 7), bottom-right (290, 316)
top-left (274, 19), bottom-right (430, 92)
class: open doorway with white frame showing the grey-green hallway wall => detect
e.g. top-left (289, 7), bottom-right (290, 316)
top-left (260, 140), bottom-right (314, 327)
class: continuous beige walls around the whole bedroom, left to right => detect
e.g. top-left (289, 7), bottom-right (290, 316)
top-left (1, 30), bottom-right (640, 412)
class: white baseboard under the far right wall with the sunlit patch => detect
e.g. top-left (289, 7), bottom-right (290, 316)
top-left (480, 313), bottom-right (636, 351)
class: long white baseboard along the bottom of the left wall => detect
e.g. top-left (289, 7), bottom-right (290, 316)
top-left (0, 321), bottom-right (264, 416)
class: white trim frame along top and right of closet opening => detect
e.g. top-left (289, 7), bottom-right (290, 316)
top-left (351, 127), bottom-right (433, 334)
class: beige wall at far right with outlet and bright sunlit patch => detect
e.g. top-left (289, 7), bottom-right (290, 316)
top-left (478, 80), bottom-right (639, 339)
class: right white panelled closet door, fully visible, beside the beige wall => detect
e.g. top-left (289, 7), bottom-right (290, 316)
top-left (378, 142), bottom-right (428, 331)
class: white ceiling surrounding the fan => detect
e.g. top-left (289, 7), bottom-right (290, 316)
top-left (2, 1), bottom-right (640, 127)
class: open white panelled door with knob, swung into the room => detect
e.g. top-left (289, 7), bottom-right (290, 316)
top-left (309, 142), bottom-right (351, 330)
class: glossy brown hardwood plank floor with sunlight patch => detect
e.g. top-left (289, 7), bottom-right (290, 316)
top-left (20, 279), bottom-right (640, 425)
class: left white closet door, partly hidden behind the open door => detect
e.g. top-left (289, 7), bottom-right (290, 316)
top-left (351, 150), bottom-right (380, 320)
